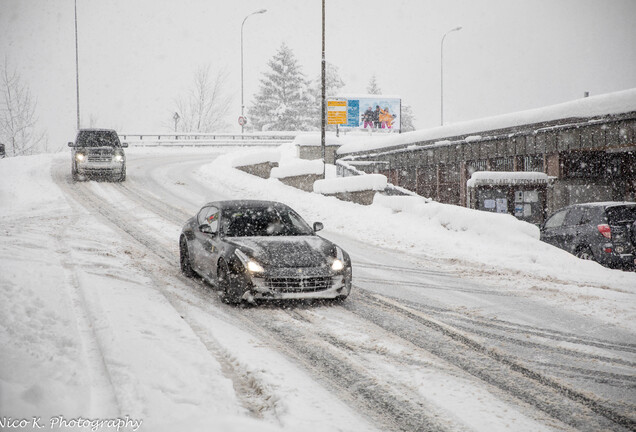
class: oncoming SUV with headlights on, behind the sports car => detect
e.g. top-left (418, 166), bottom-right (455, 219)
top-left (68, 129), bottom-right (128, 181)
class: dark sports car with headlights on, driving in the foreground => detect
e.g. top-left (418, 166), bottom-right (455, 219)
top-left (179, 201), bottom-right (351, 303)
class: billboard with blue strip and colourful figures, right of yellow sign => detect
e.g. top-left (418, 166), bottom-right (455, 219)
top-left (342, 95), bottom-right (402, 132)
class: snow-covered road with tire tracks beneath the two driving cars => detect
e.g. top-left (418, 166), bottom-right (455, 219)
top-left (0, 150), bottom-right (636, 431)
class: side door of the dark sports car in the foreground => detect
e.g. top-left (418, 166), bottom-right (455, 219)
top-left (193, 206), bottom-right (220, 280)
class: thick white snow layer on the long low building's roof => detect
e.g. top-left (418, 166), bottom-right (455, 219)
top-left (338, 88), bottom-right (636, 154)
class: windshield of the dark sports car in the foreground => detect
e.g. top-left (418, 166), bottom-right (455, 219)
top-left (222, 207), bottom-right (313, 237)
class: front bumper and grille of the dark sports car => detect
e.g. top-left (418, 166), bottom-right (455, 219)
top-left (246, 267), bottom-right (351, 300)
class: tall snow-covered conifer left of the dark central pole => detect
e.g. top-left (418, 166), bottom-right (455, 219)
top-left (248, 43), bottom-right (315, 131)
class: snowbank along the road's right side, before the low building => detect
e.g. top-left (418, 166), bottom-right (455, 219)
top-left (198, 145), bottom-right (636, 329)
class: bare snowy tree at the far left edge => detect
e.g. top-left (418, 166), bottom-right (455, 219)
top-left (0, 59), bottom-right (46, 156)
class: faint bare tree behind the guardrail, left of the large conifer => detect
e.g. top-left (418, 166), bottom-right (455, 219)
top-left (176, 66), bottom-right (232, 133)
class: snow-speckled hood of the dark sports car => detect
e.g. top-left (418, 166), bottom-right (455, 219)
top-left (226, 235), bottom-right (335, 268)
